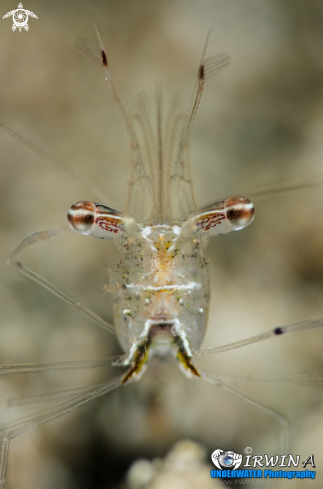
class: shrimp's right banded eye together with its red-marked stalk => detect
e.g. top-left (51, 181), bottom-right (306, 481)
top-left (188, 197), bottom-right (255, 236)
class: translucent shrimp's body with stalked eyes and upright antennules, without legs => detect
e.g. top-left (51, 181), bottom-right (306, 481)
top-left (68, 33), bottom-right (254, 382)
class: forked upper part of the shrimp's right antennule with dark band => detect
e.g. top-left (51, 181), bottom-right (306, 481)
top-left (186, 30), bottom-right (230, 139)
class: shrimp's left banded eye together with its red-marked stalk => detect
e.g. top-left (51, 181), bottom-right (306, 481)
top-left (67, 200), bottom-right (124, 239)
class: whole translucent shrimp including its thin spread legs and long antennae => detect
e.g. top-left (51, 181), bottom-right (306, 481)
top-left (0, 33), bottom-right (316, 480)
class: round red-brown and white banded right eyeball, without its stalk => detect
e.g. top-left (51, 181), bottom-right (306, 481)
top-left (224, 197), bottom-right (255, 231)
